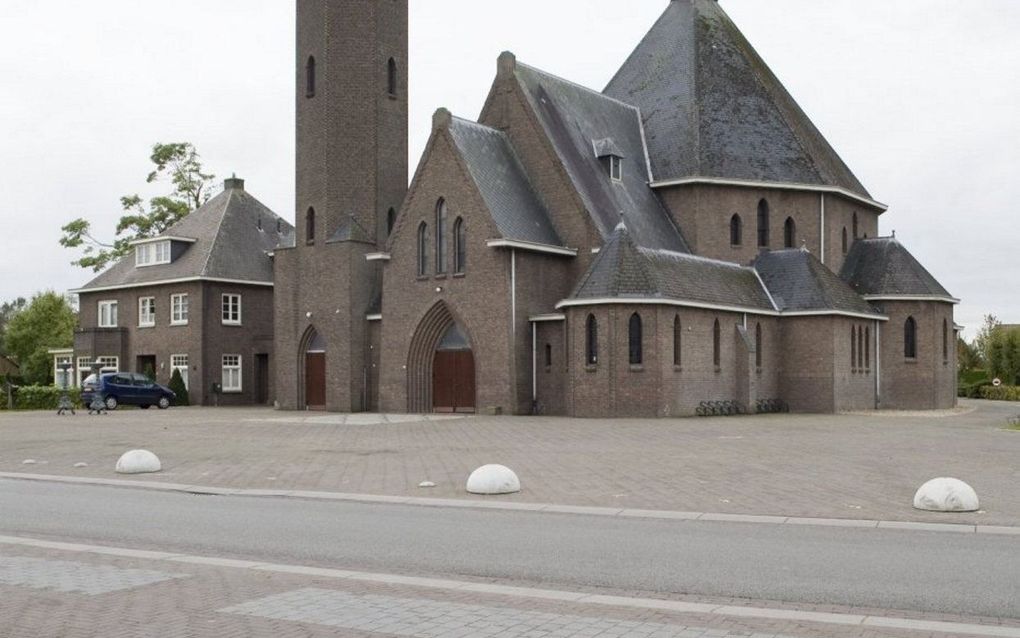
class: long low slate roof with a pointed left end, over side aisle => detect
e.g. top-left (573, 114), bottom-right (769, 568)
top-left (568, 225), bottom-right (775, 310)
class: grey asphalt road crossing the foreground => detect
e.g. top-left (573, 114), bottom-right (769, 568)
top-left (0, 480), bottom-right (1020, 619)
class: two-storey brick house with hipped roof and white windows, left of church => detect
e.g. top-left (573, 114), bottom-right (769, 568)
top-left (64, 178), bottom-right (294, 405)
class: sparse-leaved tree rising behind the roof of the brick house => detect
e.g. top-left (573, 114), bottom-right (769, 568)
top-left (60, 142), bottom-right (214, 272)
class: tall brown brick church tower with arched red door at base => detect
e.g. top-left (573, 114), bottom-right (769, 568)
top-left (274, 0), bottom-right (408, 411)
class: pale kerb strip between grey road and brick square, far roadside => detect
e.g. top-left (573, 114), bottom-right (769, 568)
top-left (0, 472), bottom-right (1020, 536)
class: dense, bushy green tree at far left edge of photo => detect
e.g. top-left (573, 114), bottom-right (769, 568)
top-left (4, 291), bottom-right (78, 384)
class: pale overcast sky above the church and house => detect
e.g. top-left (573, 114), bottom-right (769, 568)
top-left (0, 0), bottom-right (1020, 335)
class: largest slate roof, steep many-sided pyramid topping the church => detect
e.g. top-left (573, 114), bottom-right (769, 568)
top-left (605, 0), bottom-right (870, 199)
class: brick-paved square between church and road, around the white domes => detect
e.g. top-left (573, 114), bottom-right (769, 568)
top-left (0, 401), bottom-right (1020, 526)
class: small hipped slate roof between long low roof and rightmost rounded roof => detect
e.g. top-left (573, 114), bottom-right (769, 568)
top-left (754, 248), bottom-right (878, 314)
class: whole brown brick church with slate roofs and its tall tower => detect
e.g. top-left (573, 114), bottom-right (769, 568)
top-left (273, 0), bottom-right (958, 416)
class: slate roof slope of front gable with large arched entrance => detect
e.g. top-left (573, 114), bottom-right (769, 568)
top-left (449, 117), bottom-right (562, 246)
